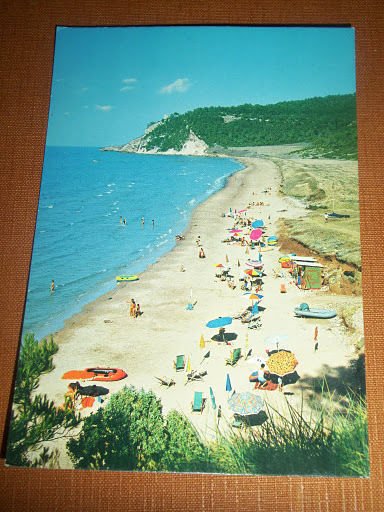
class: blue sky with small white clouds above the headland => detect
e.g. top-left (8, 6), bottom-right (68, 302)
top-left (47, 27), bottom-right (355, 147)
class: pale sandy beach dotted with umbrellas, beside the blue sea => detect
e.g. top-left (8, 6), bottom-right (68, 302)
top-left (39, 158), bottom-right (361, 467)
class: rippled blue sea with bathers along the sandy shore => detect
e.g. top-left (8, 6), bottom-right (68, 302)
top-left (22, 147), bottom-right (242, 339)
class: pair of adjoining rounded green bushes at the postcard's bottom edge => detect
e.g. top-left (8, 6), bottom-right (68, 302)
top-left (68, 387), bottom-right (207, 471)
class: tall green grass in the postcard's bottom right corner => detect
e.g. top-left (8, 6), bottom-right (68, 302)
top-left (213, 396), bottom-right (369, 476)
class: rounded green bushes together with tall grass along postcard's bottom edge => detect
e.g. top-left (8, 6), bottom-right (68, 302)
top-left (67, 388), bottom-right (369, 476)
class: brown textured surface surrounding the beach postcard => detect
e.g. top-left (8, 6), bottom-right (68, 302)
top-left (0, 0), bottom-right (384, 512)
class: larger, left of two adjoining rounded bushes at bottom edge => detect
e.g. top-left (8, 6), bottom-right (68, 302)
top-left (67, 387), bottom-right (167, 471)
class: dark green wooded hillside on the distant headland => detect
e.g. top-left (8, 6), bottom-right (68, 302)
top-left (136, 94), bottom-right (357, 159)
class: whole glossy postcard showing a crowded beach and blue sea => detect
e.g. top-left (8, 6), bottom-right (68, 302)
top-left (6, 26), bottom-right (369, 477)
